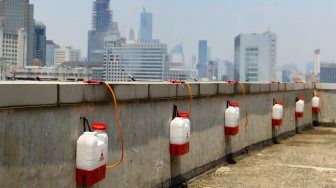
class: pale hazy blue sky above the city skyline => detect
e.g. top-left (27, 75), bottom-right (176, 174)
top-left (30, 0), bottom-right (336, 71)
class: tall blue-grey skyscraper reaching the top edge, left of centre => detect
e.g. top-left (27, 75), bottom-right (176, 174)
top-left (88, 0), bottom-right (113, 62)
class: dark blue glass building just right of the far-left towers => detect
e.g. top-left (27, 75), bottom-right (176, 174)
top-left (33, 21), bottom-right (47, 65)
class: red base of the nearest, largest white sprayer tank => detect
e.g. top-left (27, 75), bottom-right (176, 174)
top-left (76, 165), bottom-right (106, 186)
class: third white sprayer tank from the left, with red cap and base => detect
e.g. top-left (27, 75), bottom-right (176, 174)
top-left (225, 102), bottom-right (240, 136)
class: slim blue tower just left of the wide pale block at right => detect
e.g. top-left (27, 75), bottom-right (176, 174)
top-left (197, 40), bottom-right (208, 78)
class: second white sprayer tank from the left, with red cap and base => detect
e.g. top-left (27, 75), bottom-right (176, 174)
top-left (170, 113), bottom-right (190, 155)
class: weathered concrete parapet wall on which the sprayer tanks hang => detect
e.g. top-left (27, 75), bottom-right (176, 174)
top-left (0, 82), bottom-right (330, 187)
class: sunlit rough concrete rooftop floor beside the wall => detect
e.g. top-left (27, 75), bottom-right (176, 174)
top-left (187, 126), bottom-right (336, 188)
